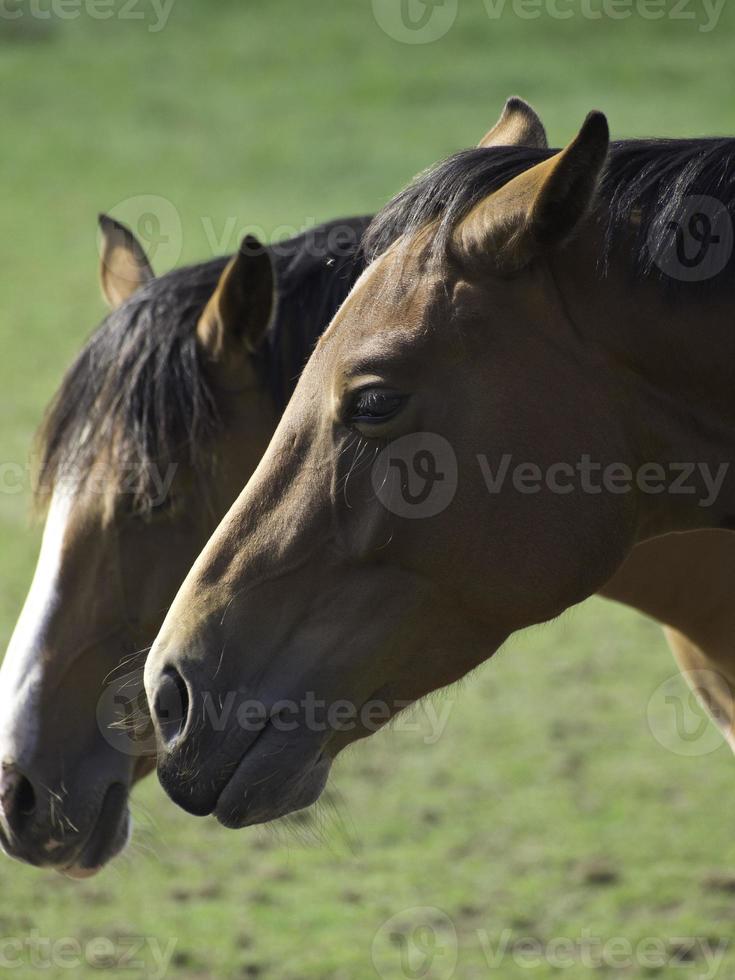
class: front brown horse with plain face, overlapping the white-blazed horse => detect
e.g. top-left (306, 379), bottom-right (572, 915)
top-left (145, 113), bottom-right (735, 826)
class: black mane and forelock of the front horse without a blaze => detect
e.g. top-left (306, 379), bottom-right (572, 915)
top-left (363, 139), bottom-right (735, 289)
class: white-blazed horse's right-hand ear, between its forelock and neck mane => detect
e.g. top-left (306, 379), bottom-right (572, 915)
top-left (197, 235), bottom-right (275, 362)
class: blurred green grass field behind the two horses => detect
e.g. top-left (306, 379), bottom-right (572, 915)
top-left (0, 0), bottom-right (735, 980)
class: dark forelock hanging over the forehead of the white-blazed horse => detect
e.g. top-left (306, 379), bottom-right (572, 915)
top-left (36, 258), bottom-right (227, 510)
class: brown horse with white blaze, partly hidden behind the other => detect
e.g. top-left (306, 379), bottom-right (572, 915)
top-left (0, 217), bottom-right (367, 877)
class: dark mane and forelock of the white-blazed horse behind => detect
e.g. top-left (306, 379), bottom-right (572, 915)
top-left (35, 218), bottom-right (368, 512)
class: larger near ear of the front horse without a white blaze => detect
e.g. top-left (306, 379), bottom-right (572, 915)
top-left (454, 112), bottom-right (610, 274)
